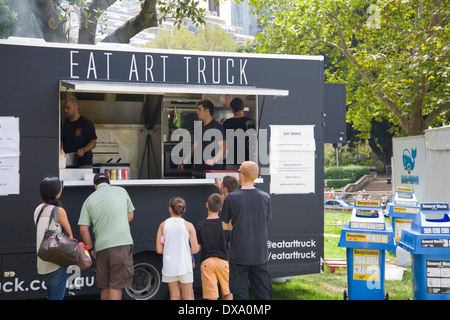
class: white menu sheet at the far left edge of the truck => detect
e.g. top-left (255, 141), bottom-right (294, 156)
top-left (0, 117), bottom-right (20, 196)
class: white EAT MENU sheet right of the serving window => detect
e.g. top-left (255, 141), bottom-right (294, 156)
top-left (270, 125), bottom-right (316, 194)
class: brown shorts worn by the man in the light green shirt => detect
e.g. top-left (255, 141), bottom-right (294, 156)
top-left (97, 245), bottom-right (134, 289)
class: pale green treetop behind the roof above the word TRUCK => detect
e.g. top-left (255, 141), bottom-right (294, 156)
top-left (145, 25), bottom-right (238, 52)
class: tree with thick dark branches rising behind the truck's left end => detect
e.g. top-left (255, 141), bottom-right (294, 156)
top-left (15, 0), bottom-right (205, 44)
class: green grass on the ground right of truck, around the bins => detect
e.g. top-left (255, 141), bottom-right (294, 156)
top-left (271, 212), bottom-right (414, 300)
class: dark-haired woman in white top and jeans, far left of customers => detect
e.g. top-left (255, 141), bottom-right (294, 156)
top-left (34, 177), bottom-right (73, 300)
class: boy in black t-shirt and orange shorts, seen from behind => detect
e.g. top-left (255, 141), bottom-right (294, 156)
top-left (197, 193), bottom-right (233, 300)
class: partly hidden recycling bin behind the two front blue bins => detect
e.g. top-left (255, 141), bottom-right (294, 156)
top-left (386, 187), bottom-right (420, 251)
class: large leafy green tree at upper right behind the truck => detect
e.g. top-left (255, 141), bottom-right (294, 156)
top-left (249, 0), bottom-right (450, 135)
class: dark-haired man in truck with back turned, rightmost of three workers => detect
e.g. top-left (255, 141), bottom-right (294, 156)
top-left (223, 98), bottom-right (255, 170)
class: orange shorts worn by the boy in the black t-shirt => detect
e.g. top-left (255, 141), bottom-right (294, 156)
top-left (200, 257), bottom-right (230, 299)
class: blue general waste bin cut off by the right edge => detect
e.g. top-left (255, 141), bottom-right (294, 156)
top-left (398, 203), bottom-right (450, 300)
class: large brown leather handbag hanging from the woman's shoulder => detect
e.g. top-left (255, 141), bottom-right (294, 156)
top-left (36, 206), bottom-right (80, 267)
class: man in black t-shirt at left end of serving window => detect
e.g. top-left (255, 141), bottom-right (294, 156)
top-left (62, 96), bottom-right (97, 167)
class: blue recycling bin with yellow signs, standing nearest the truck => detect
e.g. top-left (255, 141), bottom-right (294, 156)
top-left (338, 200), bottom-right (395, 300)
